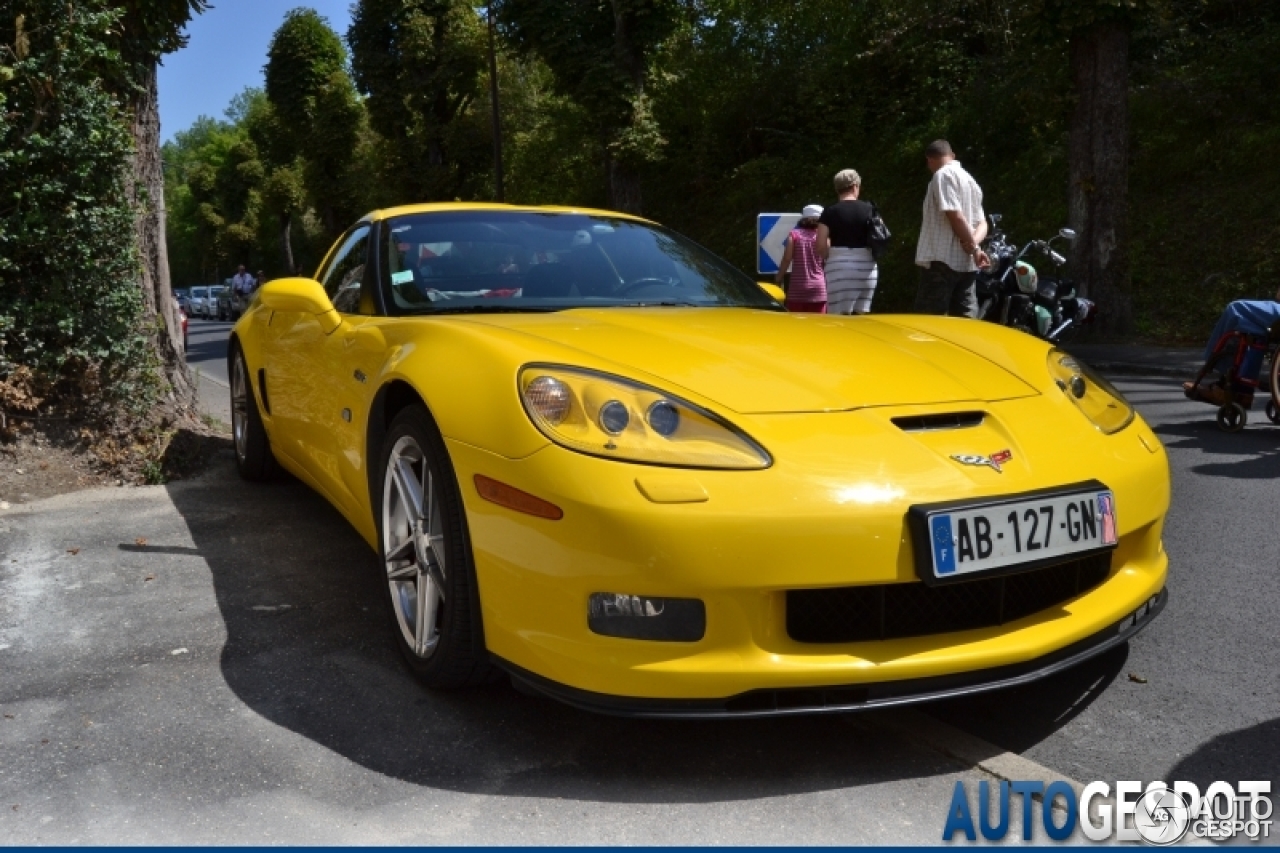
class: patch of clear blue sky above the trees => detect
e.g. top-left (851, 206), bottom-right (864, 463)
top-left (160, 0), bottom-right (352, 140)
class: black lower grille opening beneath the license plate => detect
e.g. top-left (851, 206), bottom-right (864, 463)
top-left (787, 552), bottom-right (1111, 643)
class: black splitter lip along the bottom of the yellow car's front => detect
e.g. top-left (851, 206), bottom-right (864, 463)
top-left (493, 581), bottom-right (1169, 720)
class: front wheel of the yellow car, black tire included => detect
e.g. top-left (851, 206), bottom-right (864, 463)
top-left (371, 405), bottom-right (494, 688)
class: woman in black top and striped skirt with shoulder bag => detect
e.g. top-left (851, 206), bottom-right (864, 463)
top-left (818, 169), bottom-right (879, 314)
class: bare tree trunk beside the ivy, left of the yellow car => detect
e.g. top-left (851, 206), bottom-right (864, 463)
top-left (131, 65), bottom-right (196, 414)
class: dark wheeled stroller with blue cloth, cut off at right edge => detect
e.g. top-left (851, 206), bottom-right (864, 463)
top-left (1185, 321), bottom-right (1280, 433)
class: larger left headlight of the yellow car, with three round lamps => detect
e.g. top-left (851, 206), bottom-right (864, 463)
top-left (520, 364), bottom-right (773, 470)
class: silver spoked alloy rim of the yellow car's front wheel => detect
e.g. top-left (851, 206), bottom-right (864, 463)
top-left (383, 435), bottom-right (445, 658)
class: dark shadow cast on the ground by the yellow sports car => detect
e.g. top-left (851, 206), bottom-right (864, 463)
top-left (169, 452), bottom-right (1123, 803)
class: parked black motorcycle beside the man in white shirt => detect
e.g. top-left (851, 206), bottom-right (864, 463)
top-left (977, 214), bottom-right (1097, 343)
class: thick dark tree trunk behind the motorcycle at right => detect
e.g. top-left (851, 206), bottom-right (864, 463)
top-left (1069, 23), bottom-right (1133, 334)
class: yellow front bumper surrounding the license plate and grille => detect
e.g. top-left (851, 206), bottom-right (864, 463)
top-left (448, 401), bottom-right (1169, 701)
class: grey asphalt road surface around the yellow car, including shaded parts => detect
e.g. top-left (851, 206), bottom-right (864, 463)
top-left (0, 320), bottom-right (1280, 844)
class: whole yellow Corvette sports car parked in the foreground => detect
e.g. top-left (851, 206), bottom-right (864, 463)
top-left (228, 205), bottom-right (1169, 716)
